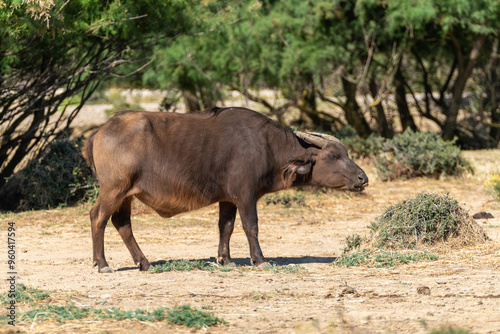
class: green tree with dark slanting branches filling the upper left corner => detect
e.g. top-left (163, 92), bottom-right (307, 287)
top-left (0, 0), bottom-right (192, 187)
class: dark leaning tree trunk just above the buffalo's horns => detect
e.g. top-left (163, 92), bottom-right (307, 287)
top-left (342, 75), bottom-right (371, 138)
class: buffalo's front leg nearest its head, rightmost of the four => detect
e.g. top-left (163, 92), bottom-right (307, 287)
top-left (238, 201), bottom-right (264, 266)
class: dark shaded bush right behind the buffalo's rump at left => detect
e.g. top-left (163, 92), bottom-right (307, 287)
top-left (20, 137), bottom-right (98, 209)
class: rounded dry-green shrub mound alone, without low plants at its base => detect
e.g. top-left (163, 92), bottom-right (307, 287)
top-left (370, 193), bottom-right (487, 249)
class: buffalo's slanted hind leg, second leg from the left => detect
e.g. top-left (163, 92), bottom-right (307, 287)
top-left (111, 197), bottom-right (151, 271)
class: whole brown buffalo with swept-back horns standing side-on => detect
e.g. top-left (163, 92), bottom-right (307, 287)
top-left (85, 108), bottom-right (368, 272)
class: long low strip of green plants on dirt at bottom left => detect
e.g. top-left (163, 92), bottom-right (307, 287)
top-left (13, 302), bottom-right (226, 328)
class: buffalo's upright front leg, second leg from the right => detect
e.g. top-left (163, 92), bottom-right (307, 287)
top-left (217, 202), bottom-right (237, 265)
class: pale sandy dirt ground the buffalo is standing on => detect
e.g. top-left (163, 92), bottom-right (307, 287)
top-left (0, 150), bottom-right (500, 333)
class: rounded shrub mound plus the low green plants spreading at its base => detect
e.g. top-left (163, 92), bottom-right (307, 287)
top-left (335, 193), bottom-right (488, 267)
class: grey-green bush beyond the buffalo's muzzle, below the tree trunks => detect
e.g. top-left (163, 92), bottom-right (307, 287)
top-left (375, 129), bottom-right (473, 181)
